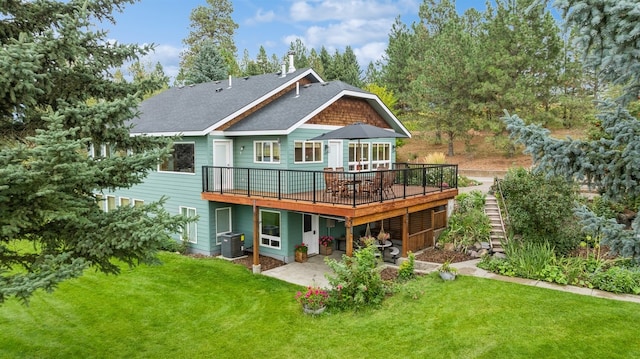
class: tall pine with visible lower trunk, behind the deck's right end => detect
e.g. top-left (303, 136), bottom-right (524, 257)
top-left (407, 0), bottom-right (478, 156)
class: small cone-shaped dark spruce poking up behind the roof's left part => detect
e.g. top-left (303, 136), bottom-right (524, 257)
top-left (185, 41), bottom-right (229, 84)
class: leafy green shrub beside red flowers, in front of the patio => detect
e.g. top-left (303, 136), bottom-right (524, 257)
top-left (325, 243), bottom-right (390, 310)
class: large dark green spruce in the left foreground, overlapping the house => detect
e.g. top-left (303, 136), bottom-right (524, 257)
top-left (0, 0), bottom-right (184, 301)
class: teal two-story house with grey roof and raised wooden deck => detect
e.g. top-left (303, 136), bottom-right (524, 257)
top-left (105, 59), bottom-right (458, 271)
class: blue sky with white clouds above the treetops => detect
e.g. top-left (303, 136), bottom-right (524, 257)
top-left (99, 0), bottom-right (485, 78)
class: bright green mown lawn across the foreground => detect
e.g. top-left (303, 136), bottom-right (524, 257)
top-left (0, 253), bottom-right (640, 358)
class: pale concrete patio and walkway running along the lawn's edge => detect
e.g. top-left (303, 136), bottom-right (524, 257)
top-left (262, 177), bottom-right (640, 304)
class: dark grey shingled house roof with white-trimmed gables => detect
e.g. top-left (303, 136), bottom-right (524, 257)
top-left (131, 69), bottom-right (410, 136)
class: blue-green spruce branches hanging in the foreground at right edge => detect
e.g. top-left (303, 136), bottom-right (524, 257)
top-left (504, 0), bottom-right (640, 262)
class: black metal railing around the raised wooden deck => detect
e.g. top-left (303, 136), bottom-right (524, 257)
top-left (202, 163), bottom-right (458, 207)
